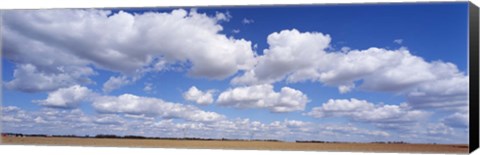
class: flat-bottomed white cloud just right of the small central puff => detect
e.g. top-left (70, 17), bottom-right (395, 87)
top-left (217, 84), bottom-right (309, 112)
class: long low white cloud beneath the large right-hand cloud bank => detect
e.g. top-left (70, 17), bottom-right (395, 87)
top-left (306, 98), bottom-right (430, 123)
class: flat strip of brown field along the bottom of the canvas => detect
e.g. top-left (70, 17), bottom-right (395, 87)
top-left (2, 137), bottom-right (468, 153)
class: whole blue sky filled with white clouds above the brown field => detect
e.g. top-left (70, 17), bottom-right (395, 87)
top-left (1, 2), bottom-right (468, 143)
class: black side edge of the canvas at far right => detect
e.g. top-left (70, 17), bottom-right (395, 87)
top-left (468, 2), bottom-right (480, 153)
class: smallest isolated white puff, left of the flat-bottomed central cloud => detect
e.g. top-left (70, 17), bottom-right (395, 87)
top-left (183, 86), bottom-right (215, 105)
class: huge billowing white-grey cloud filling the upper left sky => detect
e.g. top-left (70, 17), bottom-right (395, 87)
top-left (2, 9), bottom-right (255, 91)
